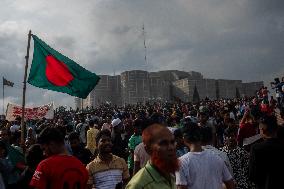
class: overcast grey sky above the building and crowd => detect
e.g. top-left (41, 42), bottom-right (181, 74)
top-left (0, 0), bottom-right (284, 112)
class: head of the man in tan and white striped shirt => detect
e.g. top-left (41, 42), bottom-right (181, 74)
top-left (96, 129), bottom-right (112, 154)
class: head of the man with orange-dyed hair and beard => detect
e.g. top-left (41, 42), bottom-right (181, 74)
top-left (142, 124), bottom-right (179, 174)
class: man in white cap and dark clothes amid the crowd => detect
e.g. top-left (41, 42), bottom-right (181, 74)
top-left (111, 118), bottom-right (127, 159)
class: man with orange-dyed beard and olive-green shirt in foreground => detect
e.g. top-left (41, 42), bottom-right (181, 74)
top-left (126, 124), bottom-right (179, 189)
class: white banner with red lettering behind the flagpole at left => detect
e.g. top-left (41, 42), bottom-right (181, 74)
top-left (6, 103), bottom-right (54, 121)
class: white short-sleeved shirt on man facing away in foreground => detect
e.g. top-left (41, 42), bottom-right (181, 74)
top-left (176, 150), bottom-right (232, 189)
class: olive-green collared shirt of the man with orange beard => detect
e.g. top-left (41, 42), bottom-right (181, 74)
top-left (126, 162), bottom-right (176, 189)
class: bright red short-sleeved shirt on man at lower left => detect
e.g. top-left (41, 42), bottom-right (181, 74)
top-left (30, 155), bottom-right (88, 189)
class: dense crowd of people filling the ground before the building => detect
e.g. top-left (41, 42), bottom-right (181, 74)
top-left (0, 87), bottom-right (284, 189)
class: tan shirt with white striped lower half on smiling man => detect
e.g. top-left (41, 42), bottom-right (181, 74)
top-left (87, 155), bottom-right (130, 189)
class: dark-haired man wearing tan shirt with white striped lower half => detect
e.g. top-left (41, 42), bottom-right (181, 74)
top-left (87, 130), bottom-right (130, 189)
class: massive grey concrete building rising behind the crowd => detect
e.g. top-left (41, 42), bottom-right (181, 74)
top-left (75, 70), bottom-right (263, 109)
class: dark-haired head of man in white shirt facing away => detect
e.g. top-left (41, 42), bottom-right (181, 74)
top-left (183, 122), bottom-right (202, 149)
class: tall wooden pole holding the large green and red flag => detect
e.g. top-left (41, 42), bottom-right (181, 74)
top-left (21, 30), bottom-right (32, 145)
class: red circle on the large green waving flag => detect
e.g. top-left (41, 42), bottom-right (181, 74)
top-left (45, 55), bottom-right (74, 87)
